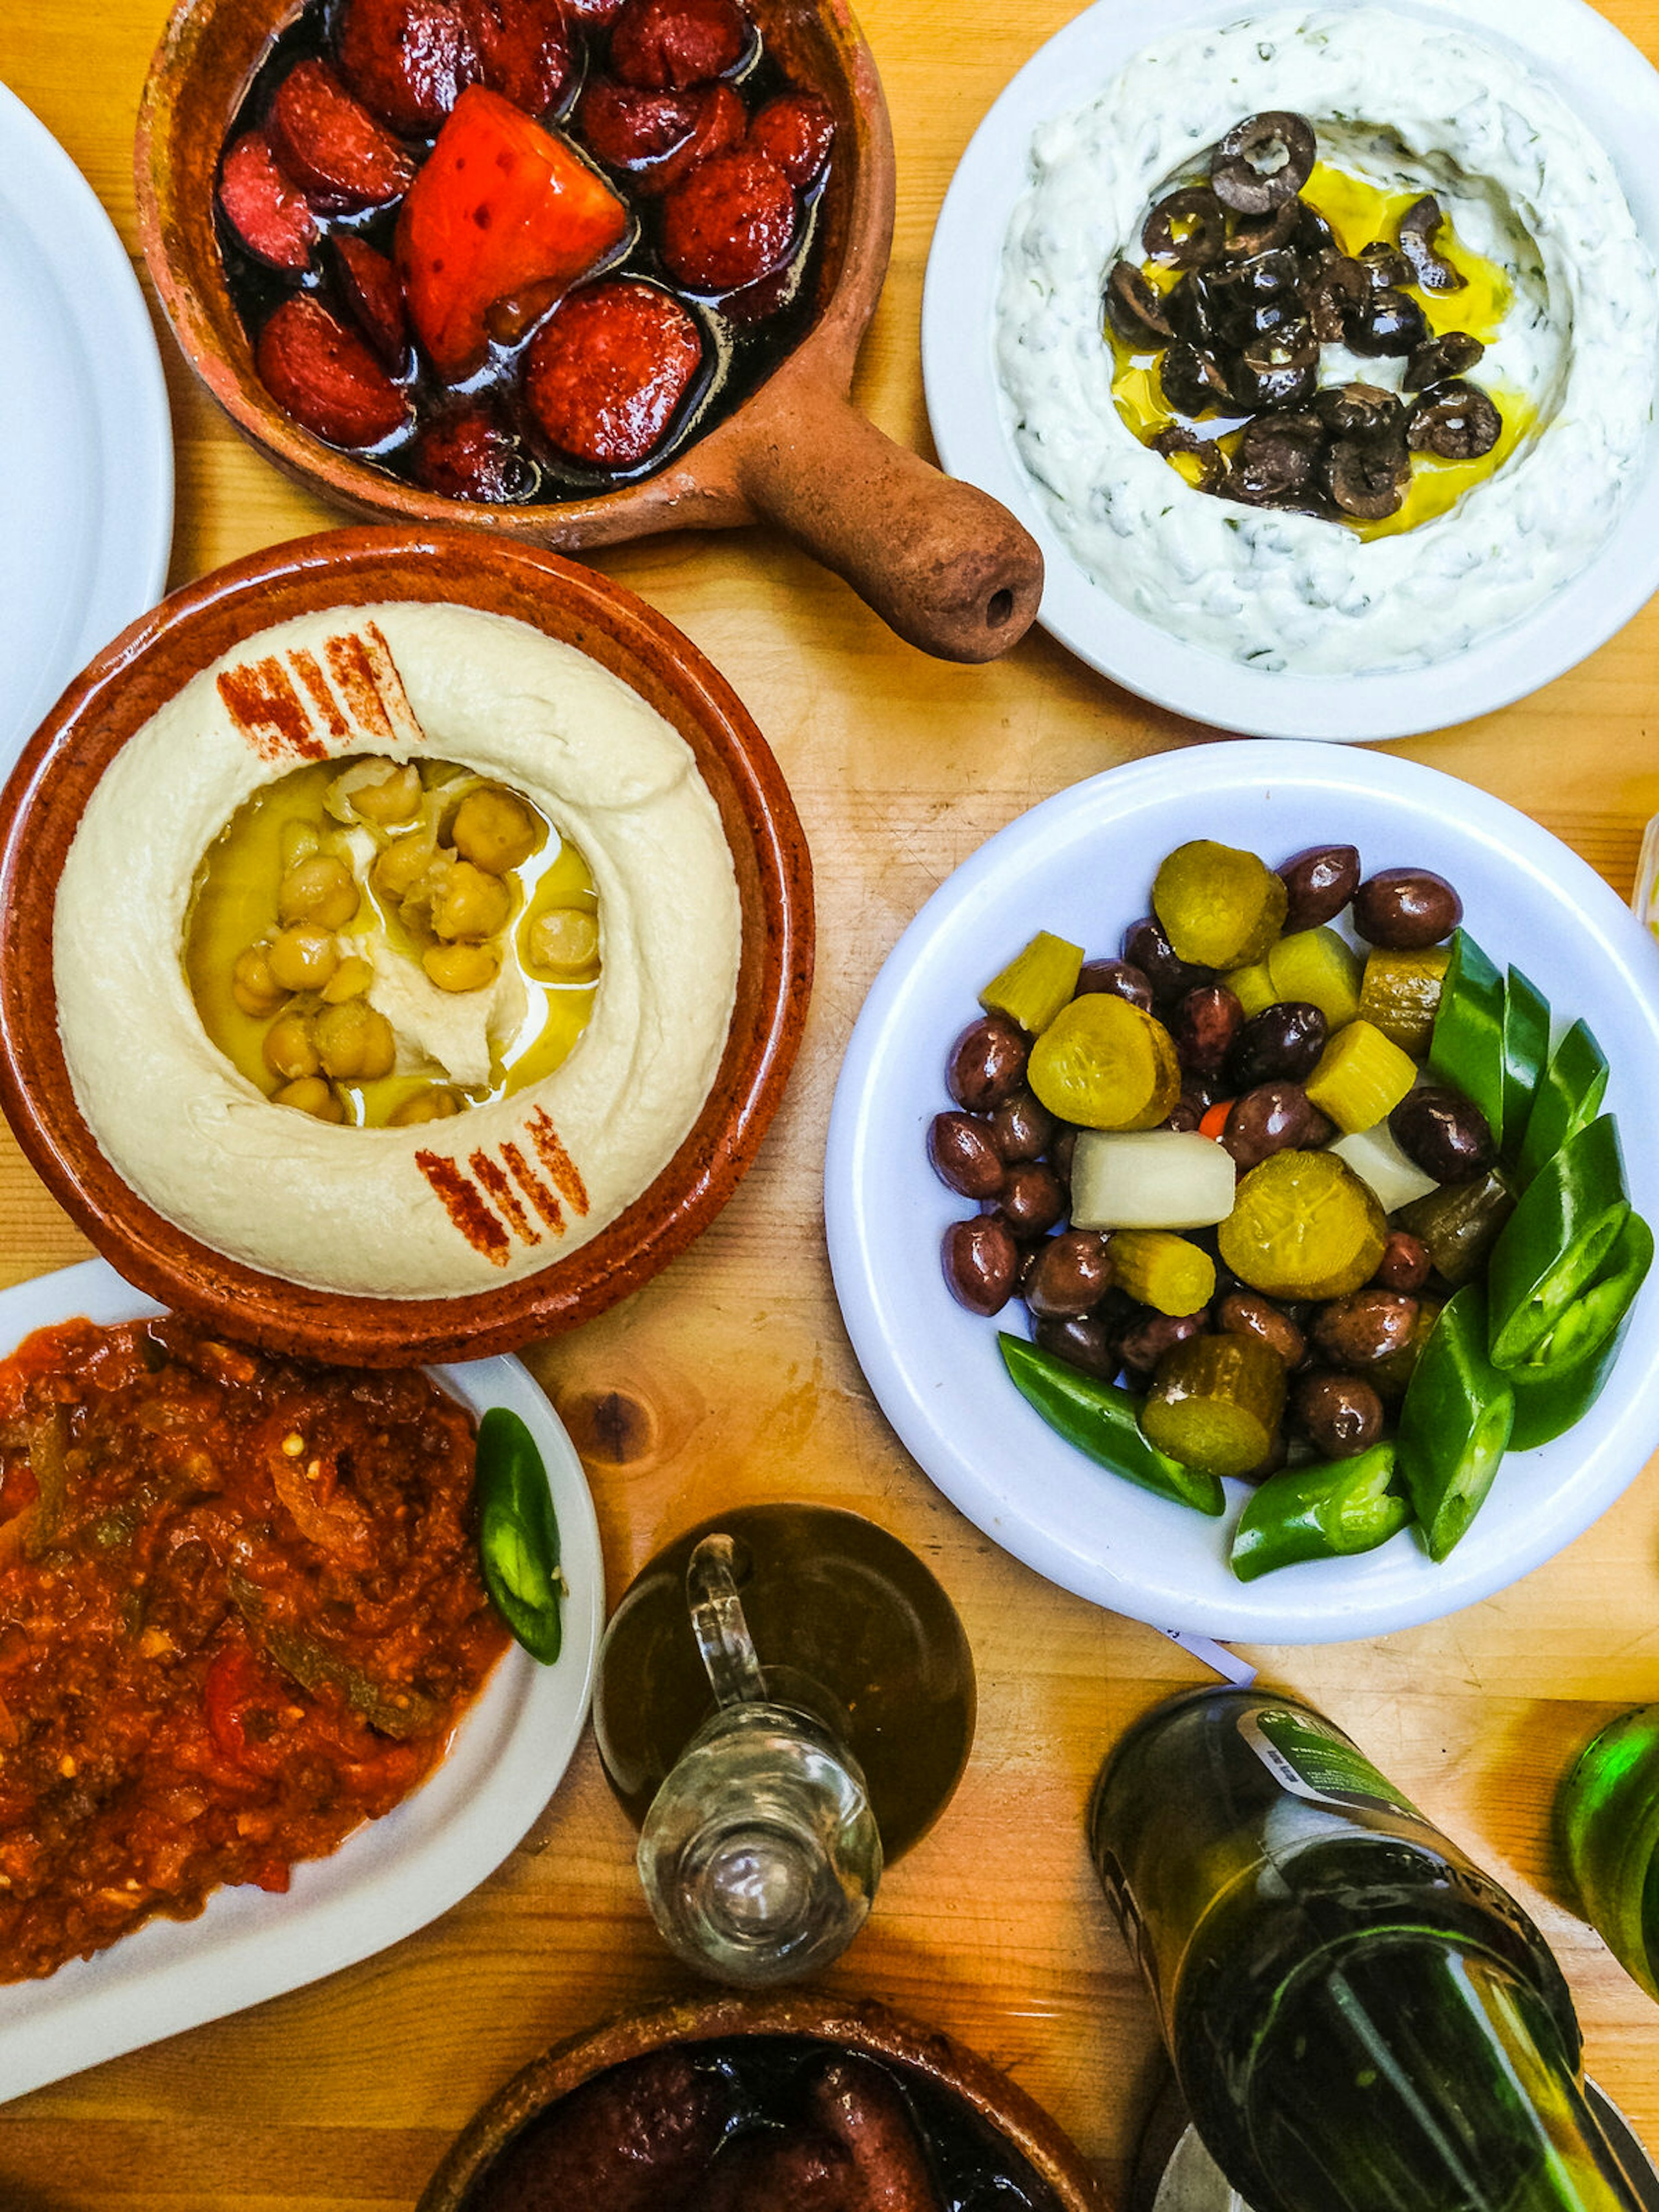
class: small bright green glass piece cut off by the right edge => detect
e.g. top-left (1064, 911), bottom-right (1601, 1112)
top-left (1557, 1706), bottom-right (1659, 1997)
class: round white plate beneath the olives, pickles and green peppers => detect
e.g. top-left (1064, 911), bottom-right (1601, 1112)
top-left (825, 743), bottom-right (1659, 1643)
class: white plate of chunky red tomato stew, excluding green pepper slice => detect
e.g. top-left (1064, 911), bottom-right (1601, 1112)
top-left (0, 1261), bottom-right (604, 2097)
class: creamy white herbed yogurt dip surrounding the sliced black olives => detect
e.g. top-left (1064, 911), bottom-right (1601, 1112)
top-left (998, 6), bottom-right (1659, 677)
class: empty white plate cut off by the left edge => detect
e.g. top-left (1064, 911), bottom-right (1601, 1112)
top-left (0, 84), bottom-right (172, 776)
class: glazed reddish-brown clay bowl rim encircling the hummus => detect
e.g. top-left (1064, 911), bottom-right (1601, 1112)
top-left (0, 529), bottom-right (812, 1367)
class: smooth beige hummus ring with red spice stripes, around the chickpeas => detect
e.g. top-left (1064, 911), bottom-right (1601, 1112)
top-left (53, 604), bottom-right (741, 1298)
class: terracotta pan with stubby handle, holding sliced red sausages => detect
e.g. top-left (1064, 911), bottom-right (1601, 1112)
top-left (137, 0), bottom-right (1042, 661)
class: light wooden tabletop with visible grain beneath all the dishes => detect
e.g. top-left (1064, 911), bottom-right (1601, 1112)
top-left (0, 0), bottom-right (1659, 2212)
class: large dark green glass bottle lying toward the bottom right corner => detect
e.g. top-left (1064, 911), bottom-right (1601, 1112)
top-left (1090, 1688), bottom-right (1639, 2212)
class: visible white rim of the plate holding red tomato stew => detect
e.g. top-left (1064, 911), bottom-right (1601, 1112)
top-left (0, 1259), bottom-right (604, 2099)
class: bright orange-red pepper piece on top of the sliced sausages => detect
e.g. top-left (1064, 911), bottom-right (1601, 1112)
top-left (396, 86), bottom-right (628, 383)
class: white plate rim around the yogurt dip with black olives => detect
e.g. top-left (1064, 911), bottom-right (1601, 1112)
top-left (922, 0), bottom-right (1659, 741)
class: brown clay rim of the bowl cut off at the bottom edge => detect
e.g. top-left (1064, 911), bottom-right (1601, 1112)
top-left (416, 1991), bottom-right (1108, 2212)
